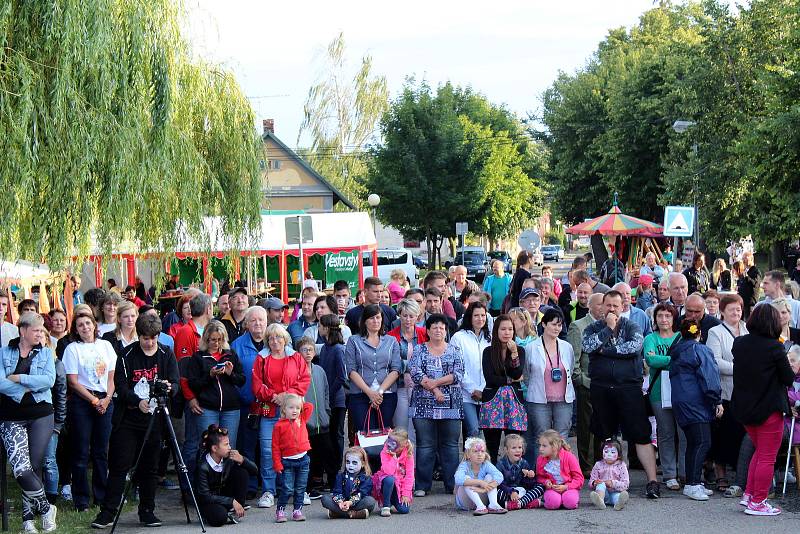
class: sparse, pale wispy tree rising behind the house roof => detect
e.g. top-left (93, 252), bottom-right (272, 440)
top-left (297, 33), bottom-right (389, 207)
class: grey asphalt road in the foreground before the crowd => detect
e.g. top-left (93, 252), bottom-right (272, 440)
top-left (117, 471), bottom-right (800, 534)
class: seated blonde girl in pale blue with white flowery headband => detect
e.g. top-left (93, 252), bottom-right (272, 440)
top-left (455, 438), bottom-right (507, 515)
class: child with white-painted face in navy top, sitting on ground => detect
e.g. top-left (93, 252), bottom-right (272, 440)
top-left (322, 447), bottom-right (376, 519)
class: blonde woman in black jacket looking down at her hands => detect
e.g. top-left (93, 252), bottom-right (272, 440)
top-left (185, 320), bottom-right (245, 443)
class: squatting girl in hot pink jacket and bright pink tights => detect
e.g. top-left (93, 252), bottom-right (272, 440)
top-left (536, 429), bottom-right (585, 510)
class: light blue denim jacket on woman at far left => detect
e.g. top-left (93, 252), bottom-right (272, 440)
top-left (0, 340), bottom-right (56, 404)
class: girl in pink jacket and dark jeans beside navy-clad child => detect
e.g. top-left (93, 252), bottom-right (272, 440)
top-left (372, 428), bottom-right (414, 517)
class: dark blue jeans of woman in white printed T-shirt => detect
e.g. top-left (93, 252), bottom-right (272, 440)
top-left (67, 395), bottom-right (114, 509)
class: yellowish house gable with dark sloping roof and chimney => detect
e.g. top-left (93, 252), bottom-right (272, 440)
top-left (261, 119), bottom-right (356, 213)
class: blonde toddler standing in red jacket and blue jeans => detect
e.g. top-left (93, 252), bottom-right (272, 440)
top-left (272, 393), bottom-right (314, 523)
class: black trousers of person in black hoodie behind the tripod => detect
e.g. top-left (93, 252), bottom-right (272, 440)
top-left (102, 419), bottom-right (161, 514)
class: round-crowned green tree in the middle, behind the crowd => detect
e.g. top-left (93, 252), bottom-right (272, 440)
top-left (366, 80), bottom-right (543, 263)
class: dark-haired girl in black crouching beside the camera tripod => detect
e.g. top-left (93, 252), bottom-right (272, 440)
top-left (195, 425), bottom-right (258, 527)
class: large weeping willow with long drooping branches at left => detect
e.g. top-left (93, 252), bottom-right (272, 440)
top-left (0, 0), bottom-right (261, 266)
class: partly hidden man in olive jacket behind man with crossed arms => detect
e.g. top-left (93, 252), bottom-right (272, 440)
top-left (567, 294), bottom-right (603, 474)
